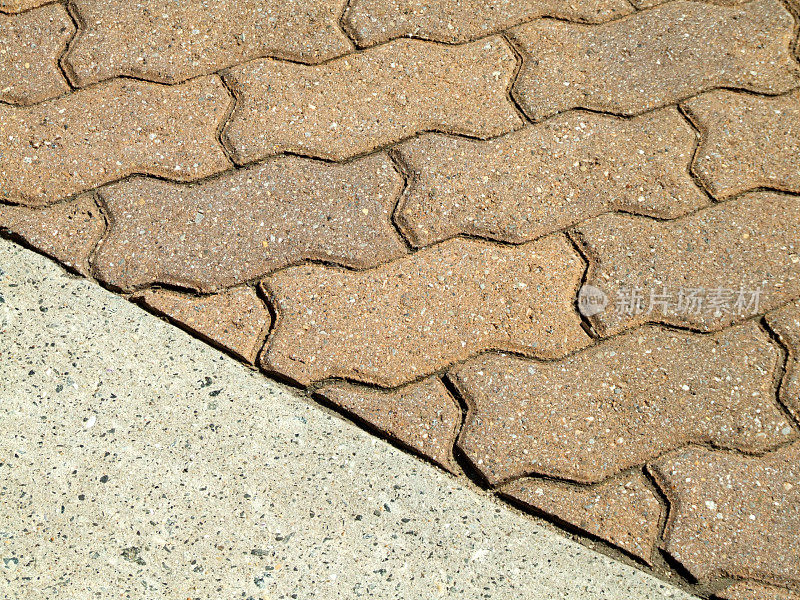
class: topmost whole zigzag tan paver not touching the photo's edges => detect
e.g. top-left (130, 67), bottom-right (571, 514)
top-left (223, 37), bottom-right (522, 162)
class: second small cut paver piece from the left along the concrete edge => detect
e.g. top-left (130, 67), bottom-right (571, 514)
top-left (134, 288), bottom-right (272, 363)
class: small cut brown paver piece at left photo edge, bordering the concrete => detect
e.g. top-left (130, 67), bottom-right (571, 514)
top-left (0, 194), bottom-right (105, 275)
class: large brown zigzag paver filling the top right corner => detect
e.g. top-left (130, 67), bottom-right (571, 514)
top-left (512, 0), bottom-right (800, 120)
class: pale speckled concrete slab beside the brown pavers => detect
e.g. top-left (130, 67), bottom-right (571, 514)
top-left (0, 240), bottom-right (689, 600)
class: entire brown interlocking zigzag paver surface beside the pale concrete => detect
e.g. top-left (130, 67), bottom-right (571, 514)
top-left (0, 0), bottom-right (800, 599)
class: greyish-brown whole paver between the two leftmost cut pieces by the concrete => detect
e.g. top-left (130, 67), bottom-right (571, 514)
top-left (95, 155), bottom-right (407, 292)
